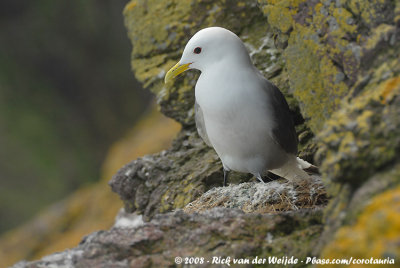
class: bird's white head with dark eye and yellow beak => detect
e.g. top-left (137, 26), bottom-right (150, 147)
top-left (165, 27), bottom-right (250, 83)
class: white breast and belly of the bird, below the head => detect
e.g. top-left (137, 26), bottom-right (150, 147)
top-left (196, 66), bottom-right (284, 174)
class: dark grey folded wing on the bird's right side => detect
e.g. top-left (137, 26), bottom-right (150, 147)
top-left (266, 80), bottom-right (298, 155)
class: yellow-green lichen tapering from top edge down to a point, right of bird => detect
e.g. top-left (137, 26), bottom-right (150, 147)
top-left (259, 0), bottom-right (361, 132)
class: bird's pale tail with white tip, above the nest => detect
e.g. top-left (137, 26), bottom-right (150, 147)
top-left (269, 157), bottom-right (319, 181)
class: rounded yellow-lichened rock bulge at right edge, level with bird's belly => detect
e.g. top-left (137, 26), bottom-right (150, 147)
top-left (317, 73), bottom-right (400, 184)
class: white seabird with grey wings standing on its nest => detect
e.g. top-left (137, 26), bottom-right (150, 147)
top-left (165, 27), bottom-right (314, 185)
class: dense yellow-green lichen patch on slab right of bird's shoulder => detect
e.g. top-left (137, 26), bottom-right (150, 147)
top-left (284, 25), bottom-right (348, 131)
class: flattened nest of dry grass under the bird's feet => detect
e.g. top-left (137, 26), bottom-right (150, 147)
top-left (184, 176), bottom-right (328, 213)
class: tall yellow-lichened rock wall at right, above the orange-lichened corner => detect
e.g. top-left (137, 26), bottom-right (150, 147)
top-left (258, 0), bottom-right (400, 258)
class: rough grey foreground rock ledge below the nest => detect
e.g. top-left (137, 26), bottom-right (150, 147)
top-left (13, 208), bottom-right (322, 268)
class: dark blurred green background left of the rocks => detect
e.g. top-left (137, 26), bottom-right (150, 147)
top-left (0, 0), bottom-right (150, 233)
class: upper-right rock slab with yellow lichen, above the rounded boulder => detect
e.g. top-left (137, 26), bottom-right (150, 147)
top-left (258, 0), bottom-right (396, 131)
